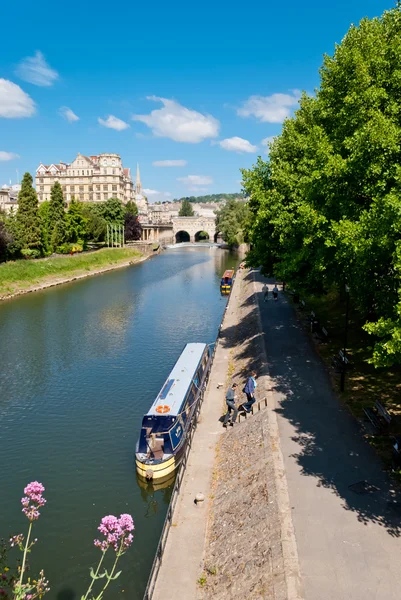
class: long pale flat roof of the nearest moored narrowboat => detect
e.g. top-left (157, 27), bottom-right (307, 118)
top-left (146, 343), bottom-right (206, 417)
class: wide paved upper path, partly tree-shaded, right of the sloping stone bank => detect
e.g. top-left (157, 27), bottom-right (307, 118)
top-left (255, 273), bottom-right (401, 600)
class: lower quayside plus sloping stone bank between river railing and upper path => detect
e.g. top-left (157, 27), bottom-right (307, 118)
top-left (149, 271), bottom-right (299, 600)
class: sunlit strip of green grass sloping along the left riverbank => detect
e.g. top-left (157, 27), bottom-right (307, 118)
top-left (0, 248), bottom-right (142, 297)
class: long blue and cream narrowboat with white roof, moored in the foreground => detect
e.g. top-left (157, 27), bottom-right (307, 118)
top-left (135, 343), bottom-right (211, 480)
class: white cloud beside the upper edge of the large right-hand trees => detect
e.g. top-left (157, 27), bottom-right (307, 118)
top-left (237, 90), bottom-right (300, 123)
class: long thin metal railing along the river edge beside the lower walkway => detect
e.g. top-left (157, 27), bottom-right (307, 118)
top-left (143, 272), bottom-right (234, 600)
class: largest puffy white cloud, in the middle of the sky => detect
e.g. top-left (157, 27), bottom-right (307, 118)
top-left (132, 96), bottom-right (220, 144)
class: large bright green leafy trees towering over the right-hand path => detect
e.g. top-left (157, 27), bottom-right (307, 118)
top-left (243, 3), bottom-right (401, 366)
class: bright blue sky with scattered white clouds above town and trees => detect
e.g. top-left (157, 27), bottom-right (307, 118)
top-left (0, 0), bottom-right (393, 201)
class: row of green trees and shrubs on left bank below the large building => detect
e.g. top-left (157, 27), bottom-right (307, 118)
top-left (0, 173), bottom-right (142, 261)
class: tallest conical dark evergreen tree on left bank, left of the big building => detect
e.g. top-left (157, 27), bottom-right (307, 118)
top-left (14, 173), bottom-right (42, 256)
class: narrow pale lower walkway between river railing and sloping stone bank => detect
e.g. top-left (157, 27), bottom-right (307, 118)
top-left (152, 273), bottom-right (241, 600)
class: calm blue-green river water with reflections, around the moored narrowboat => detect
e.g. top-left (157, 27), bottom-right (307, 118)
top-left (0, 248), bottom-right (237, 600)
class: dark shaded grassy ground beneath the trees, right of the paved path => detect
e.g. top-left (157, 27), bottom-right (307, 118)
top-left (294, 294), bottom-right (401, 466)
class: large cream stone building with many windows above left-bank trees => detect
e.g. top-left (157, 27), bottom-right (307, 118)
top-left (35, 153), bottom-right (135, 204)
